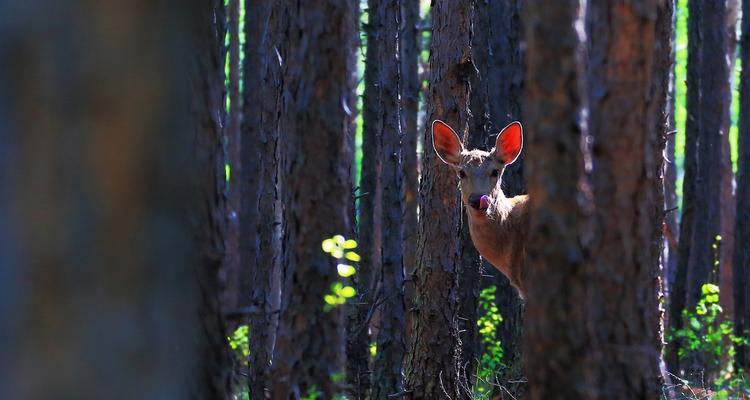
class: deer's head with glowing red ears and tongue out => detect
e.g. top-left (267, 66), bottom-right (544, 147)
top-left (432, 120), bottom-right (523, 212)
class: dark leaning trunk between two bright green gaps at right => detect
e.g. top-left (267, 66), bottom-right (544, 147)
top-left (667, 0), bottom-right (729, 374)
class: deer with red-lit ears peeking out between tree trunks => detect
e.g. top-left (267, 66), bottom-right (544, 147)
top-left (432, 120), bottom-right (529, 299)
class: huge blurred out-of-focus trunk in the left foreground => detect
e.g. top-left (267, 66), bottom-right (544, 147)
top-left (0, 1), bottom-right (230, 399)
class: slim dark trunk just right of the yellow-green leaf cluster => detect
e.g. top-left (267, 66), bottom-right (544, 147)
top-left (370, 0), bottom-right (406, 400)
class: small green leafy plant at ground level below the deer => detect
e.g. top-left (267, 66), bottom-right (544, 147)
top-left (474, 285), bottom-right (505, 399)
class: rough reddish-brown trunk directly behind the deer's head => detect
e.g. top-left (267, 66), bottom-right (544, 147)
top-left (405, 0), bottom-right (473, 399)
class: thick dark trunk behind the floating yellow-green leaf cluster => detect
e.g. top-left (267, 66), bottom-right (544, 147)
top-left (272, 0), bottom-right (356, 399)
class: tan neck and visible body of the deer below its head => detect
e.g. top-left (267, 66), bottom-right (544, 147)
top-left (466, 182), bottom-right (529, 298)
